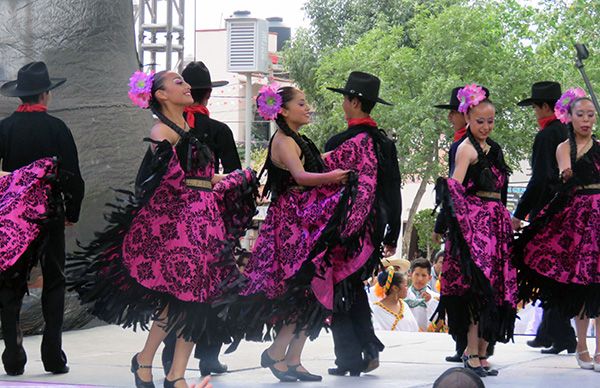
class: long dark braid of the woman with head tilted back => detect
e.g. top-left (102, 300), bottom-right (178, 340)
top-left (148, 70), bottom-right (212, 171)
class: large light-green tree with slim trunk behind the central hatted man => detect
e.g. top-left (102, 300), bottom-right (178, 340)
top-left (307, 1), bottom-right (535, 253)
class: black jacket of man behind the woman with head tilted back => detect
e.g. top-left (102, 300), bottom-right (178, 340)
top-left (190, 113), bottom-right (242, 173)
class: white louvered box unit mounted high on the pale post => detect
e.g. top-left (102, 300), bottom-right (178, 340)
top-left (226, 17), bottom-right (269, 73)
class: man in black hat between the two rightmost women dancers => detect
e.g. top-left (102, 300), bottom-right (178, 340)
top-left (512, 81), bottom-right (577, 354)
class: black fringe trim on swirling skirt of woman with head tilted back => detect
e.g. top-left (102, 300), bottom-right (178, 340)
top-left (66, 143), bottom-right (258, 343)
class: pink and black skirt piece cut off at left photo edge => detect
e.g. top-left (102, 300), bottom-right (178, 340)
top-left (0, 158), bottom-right (58, 282)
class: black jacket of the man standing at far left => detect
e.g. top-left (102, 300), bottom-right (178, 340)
top-left (0, 112), bottom-right (85, 222)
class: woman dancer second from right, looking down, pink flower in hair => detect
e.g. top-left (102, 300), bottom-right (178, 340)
top-left (436, 84), bottom-right (516, 377)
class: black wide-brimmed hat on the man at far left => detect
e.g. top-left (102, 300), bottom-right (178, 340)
top-left (0, 62), bottom-right (67, 97)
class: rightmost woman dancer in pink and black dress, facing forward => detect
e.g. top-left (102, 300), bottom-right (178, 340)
top-left (515, 89), bottom-right (600, 372)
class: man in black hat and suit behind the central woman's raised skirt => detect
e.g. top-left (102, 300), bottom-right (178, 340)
top-left (325, 71), bottom-right (402, 376)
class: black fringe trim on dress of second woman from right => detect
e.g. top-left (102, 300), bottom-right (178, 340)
top-left (432, 178), bottom-right (516, 343)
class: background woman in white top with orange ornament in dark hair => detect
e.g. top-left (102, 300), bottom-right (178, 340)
top-left (371, 267), bottom-right (419, 331)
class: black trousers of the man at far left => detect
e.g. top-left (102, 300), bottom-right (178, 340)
top-left (0, 224), bottom-right (67, 371)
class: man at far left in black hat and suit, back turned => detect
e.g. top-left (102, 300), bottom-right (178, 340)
top-left (0, 62), bottom-right (84, 376)
